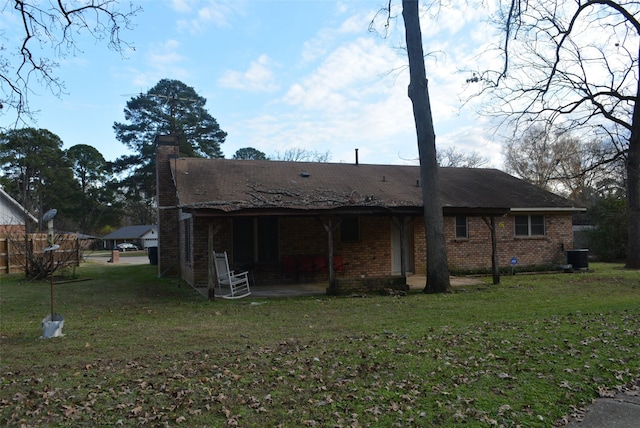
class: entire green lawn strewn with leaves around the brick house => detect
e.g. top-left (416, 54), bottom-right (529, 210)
top-left (0, 263), bottom-right (640, 427)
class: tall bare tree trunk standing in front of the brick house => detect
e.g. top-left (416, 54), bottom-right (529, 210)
top-left (402, 0), bottom-right (451, 293)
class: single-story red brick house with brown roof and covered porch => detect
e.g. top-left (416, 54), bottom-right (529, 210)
top-left (156, 136), bottom-right (581, 292)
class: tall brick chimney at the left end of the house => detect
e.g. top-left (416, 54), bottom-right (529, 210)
top-left (155, 135), bottom-right (180, 276)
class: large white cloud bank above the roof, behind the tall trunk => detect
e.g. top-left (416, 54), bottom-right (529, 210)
top-left (212, 4), bottom-right (508, 167)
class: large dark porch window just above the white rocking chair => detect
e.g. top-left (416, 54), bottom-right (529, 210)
top-left (233, 217), bottom-right (278, 263)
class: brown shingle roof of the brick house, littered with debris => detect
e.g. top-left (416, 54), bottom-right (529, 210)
top-left (171, 158), bottom-right (573, 212)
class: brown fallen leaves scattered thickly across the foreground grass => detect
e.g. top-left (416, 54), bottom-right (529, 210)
top-left (0, 313), bottom-right (640, 427)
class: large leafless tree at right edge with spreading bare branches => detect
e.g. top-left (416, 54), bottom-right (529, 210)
top-left (472, 0), bottom-right (640, 269)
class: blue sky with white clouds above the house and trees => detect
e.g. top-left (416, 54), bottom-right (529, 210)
top-left (0, 0), bottom-right (502, 168)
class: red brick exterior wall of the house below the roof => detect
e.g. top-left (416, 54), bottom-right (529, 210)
top-left (184, 214), bottom-right (573, 285)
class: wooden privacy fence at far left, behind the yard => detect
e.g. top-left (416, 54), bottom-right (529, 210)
top-left (0, 233), bottom-right (81, 275)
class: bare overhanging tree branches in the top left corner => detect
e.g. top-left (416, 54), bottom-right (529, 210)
top-left (0, 0), bottom-right (141, 124)
